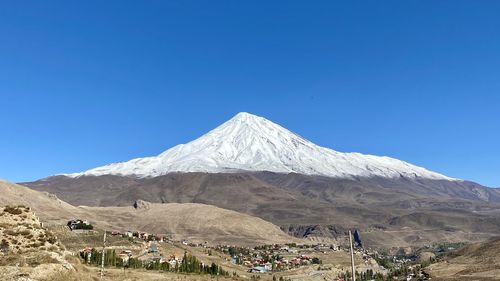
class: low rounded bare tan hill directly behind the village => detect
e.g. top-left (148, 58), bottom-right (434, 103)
top-left (83, 202), bottom-right (299, 245)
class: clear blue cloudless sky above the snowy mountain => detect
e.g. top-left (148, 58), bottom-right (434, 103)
top-left (0, 0), bottom-right (500, 187)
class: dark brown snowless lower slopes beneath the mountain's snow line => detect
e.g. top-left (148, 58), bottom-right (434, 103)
top-left (23, 172), bottom-right (500, 248)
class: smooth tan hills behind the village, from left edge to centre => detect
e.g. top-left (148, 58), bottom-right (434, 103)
top-left (0, 181), bottom-right (297, 245)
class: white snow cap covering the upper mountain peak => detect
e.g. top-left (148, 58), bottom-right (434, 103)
top-left (66, 112), bottom-right (454, 180)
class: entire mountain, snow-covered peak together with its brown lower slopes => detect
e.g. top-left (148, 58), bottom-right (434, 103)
top-left (23, 113), bottom-right (500, 247)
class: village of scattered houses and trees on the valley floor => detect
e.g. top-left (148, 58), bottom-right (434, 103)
top-left (64, 217), bottom-right (436, 280)
